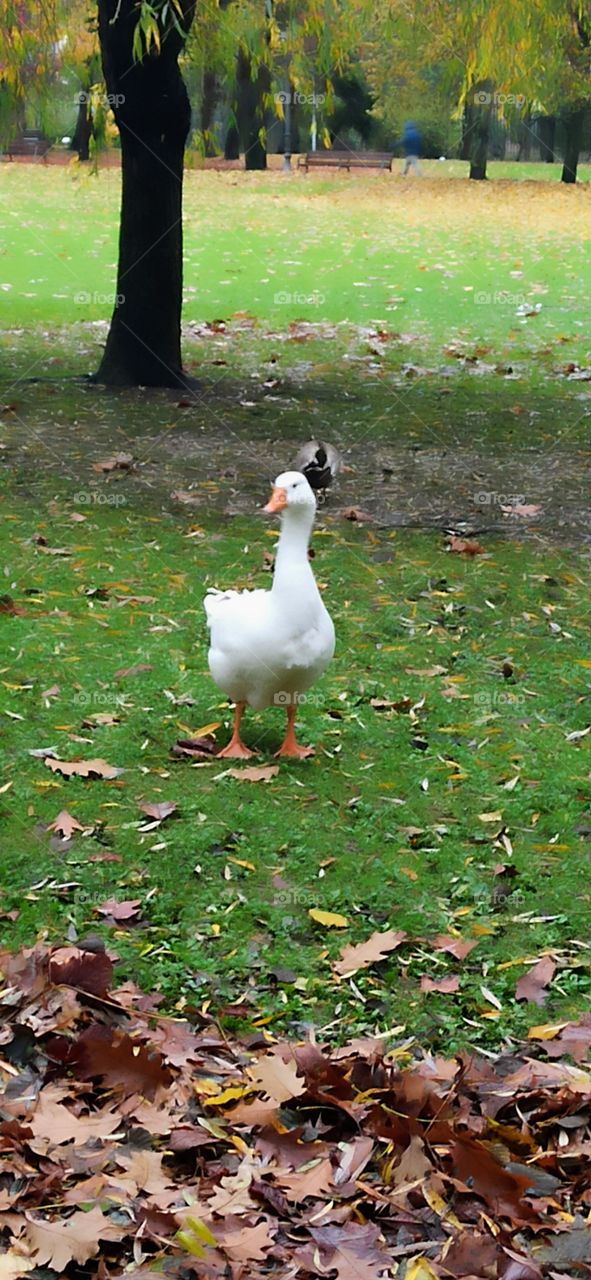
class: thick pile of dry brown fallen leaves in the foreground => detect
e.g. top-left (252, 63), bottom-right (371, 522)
top-left (0, 940), bottom-right (591, 1280)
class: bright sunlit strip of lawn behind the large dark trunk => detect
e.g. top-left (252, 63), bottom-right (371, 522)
top-left (0, 161), bottom-right (591, 358)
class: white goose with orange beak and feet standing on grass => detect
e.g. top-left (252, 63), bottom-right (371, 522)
top-left (203, 471), bottom-right (335, 758)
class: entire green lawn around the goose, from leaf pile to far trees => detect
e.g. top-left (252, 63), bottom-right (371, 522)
top-left (0, 166), bottom-right (591, 1051)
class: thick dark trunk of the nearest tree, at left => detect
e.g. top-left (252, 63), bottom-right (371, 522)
top-left (96, 0), bottom-right (194, 387)
